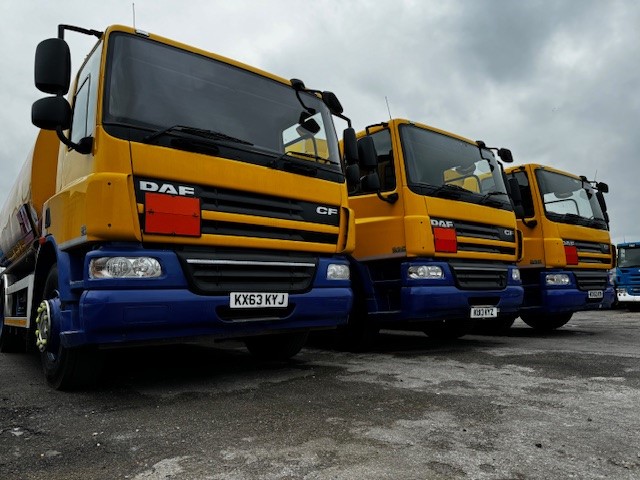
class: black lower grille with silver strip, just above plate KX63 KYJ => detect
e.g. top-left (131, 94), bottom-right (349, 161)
top-left (176, 249), bottom-right (318, 295)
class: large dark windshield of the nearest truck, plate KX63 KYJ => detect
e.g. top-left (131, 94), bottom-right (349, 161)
top-left (103, 33), bottom-right (340, 171)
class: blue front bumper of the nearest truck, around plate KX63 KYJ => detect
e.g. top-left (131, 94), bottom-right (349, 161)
top-left (59, 248), bottom-right (353, 347)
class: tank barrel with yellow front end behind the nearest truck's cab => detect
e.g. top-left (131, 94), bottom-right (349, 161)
top-left (0, 130), bottom-right (60, 268)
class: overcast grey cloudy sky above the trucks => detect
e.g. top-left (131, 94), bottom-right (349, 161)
top-left (0, 0), bottom-right (640, 243)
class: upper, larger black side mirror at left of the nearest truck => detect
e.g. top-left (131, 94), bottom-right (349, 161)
top-left (34, 38), bottom-right (71, 95)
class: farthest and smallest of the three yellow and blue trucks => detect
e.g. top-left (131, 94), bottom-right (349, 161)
top-left (506, 164), bottom-right (615, 330)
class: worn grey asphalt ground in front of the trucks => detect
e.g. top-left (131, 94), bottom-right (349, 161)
top-left (0, 310), bottom-right (640, 480)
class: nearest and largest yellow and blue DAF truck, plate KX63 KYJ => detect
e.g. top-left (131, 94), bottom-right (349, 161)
top-left (0, 25), bottom-right (356, 389)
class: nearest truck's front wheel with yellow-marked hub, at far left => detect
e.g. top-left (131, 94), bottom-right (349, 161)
top-left (36, 265), bottom-right (102, 390)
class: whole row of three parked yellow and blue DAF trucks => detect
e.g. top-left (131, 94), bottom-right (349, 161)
top-left (0, 25), bottom-right (615, 389)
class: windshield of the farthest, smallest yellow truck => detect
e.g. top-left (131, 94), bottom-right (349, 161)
top-left (536, 169), bottom-right (607, 229)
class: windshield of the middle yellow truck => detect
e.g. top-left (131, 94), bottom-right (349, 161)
top-left (400, 125), bottom-right (512, 210)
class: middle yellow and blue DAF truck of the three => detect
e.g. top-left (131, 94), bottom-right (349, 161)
top-left (342, 119), bottom-right (523, 343)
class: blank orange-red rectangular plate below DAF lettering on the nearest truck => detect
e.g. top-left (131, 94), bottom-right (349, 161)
top-left (144, 193), bottom-right (200, 237)
